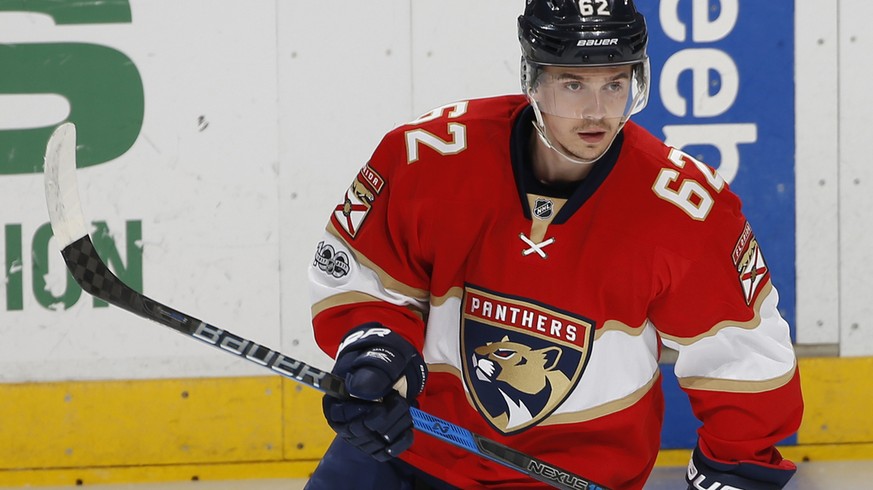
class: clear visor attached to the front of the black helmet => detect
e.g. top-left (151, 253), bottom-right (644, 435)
top-left (525, 59), bottom-right (649, 120)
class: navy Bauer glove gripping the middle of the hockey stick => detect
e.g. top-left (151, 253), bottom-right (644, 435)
top-left (322, 323), bottom-right (427, 461)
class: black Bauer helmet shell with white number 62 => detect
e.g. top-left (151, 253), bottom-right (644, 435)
top-left (518, 0), bottom-right (648, 66)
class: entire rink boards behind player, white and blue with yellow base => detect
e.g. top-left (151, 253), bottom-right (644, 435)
top-left (0, 0), bottom-right (873, 483)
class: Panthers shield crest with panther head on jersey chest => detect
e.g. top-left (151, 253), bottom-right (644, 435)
top-left (461, 285), bottom-right (594, 434)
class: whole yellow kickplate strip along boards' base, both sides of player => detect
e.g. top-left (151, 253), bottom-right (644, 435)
top-left (0, 358), bottom-right (873, 485)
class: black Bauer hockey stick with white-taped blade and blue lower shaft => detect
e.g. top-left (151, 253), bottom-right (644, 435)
top-left (45, 123), bottom-right (607, 490)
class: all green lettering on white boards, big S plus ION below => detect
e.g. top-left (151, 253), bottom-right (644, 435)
top-left (0, 0), bottom-right (145, 311)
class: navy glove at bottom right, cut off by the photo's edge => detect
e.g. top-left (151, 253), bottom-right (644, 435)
top-left (685, 446), bottom-right (796, 490)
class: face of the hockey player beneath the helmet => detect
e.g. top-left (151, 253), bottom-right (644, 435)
top-left (537, 66), bottom-right (632, 160)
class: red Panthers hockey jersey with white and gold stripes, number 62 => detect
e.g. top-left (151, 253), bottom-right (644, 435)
top-left (309, 96), bottom-right (802, 489)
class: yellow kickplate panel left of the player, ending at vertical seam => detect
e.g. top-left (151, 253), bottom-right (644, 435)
top-left (0, 376), bottom-right (282, 469)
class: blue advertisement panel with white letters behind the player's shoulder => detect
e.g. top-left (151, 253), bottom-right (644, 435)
top-left (634, 0), bottom-right (796, 447)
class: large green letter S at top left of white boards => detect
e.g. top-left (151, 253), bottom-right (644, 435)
top-left (0, 0), bottom-right (145, 176)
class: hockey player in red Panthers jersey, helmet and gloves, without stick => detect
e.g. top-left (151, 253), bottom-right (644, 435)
top-left (307, 0), bottom-right (802, 490)
